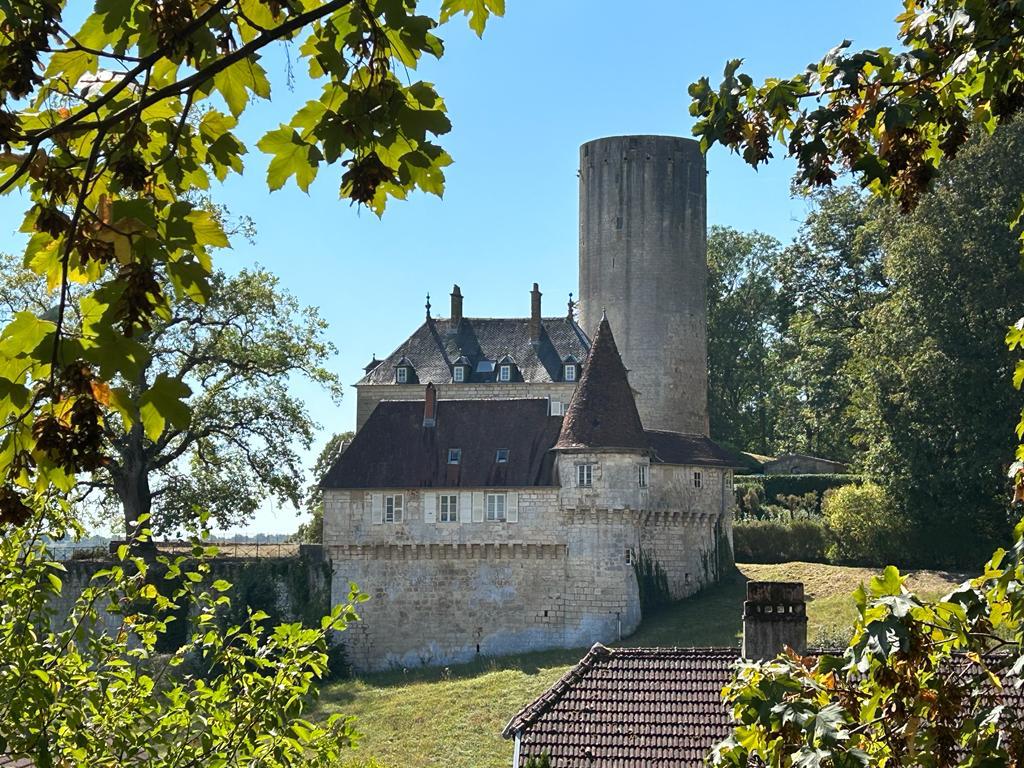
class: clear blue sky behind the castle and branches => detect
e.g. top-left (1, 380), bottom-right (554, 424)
top-left (0, 0), bottom-right (902, 532)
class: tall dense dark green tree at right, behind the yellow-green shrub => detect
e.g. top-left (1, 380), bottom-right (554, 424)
top-left (856, 120), bottom-right (1024, 567)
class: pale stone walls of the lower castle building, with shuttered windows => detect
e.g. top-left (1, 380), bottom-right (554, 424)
top-left (324, 460), bottom-right (732, 670)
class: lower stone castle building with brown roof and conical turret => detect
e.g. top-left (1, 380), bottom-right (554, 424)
top-left (322, 315), bottom-right (735, 670)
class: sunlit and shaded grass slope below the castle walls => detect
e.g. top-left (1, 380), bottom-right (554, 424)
top-left (318, 562), bottom-right (964, 768)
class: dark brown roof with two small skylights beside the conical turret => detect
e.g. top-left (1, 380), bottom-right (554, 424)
top-left (321, 397), bottom-right (561, 488)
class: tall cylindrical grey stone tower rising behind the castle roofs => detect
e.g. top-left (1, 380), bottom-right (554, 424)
top-left (580, 136), bottom-right (708, 434)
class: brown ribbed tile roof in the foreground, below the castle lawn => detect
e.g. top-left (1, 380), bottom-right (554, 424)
top-left (504, 644), bottom-right (739, 768)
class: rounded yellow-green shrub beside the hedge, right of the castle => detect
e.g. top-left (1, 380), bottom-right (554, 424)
top-left (821, 482), bottom-right (907, 565)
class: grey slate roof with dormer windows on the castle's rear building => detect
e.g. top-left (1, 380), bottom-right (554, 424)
top-left (356, 317), bottom-right (590, 386)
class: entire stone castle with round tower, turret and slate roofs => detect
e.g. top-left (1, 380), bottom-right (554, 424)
top-left (322, 136), bottom-right (735, 670)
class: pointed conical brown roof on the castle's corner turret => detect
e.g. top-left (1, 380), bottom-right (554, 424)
top-left (555, 316), bottom-right (649, 451)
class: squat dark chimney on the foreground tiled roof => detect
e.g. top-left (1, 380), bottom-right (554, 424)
top-left (742, 582), bottom-right (807, 662)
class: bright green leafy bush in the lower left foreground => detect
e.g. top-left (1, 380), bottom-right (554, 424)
top-left (0, 518), bottom-right (366, 768)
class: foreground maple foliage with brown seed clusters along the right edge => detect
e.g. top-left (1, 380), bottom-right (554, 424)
top-left (690, 0), bottom-right (1024, 767)
